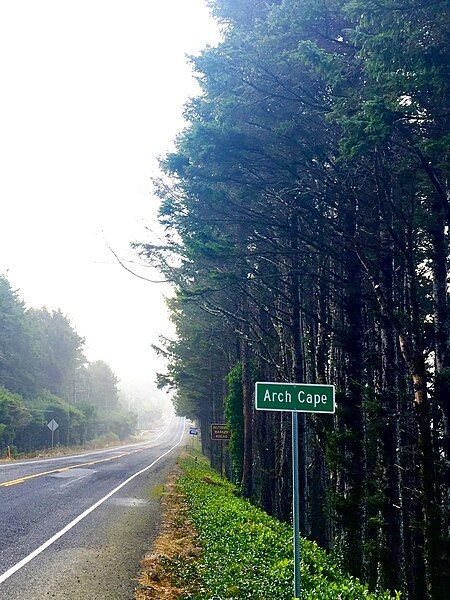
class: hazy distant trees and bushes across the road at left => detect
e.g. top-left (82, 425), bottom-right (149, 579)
top-left (0, 276), bottom-right (137, 457)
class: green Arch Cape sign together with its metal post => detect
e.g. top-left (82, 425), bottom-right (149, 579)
top-left (255, 381), bottom-right (335, 600)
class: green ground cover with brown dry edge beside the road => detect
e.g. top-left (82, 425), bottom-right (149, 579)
top-left (137, 455), bottom-right (400, 600)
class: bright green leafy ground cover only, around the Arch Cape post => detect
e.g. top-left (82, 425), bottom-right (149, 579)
top-left (178, 458), bottom-right (400, 600)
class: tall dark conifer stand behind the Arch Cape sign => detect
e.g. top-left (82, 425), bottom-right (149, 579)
top-left (137, 0), bottom-right (450, 600)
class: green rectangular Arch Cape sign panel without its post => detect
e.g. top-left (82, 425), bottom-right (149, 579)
top-left (255, 381), bottom-right (334, 413)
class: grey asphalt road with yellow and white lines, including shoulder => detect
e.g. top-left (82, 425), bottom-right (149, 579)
top-left (0, 418), bottom-right (184, 600)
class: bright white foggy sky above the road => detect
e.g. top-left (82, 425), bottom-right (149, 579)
top-left (0, 0), bottom-right (219, 408)
